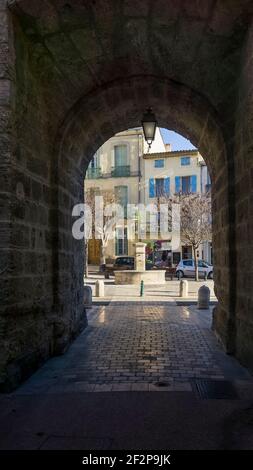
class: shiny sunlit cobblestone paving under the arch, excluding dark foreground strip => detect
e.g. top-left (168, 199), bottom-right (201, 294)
top-left (15, 302), bottom-right (251, 394)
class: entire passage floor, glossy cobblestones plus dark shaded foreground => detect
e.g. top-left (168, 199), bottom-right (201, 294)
top-left (0, 302), bottom-right (253, 453)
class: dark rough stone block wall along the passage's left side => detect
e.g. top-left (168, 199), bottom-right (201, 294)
top-left (0, 2), bottom-right (86, 390)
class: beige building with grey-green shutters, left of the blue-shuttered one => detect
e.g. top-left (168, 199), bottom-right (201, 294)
top-left (85, 128), bottom-right (166, 264)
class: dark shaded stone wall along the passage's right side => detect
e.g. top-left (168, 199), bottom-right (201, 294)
top-left (214, 20), bottom-right (253, 370)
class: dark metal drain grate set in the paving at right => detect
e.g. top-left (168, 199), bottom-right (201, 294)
top-left (194, 379), bottom-right (238, 400)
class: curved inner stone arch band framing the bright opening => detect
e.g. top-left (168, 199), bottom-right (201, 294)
top-left (54, 76), bottom-right (231, 368)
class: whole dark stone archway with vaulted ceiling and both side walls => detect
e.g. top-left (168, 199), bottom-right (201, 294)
top-left (0, 0), bottom-right (253, 388)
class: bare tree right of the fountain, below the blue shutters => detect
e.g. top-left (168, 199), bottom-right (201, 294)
top-left (160, 193), bottom-right (212, 281)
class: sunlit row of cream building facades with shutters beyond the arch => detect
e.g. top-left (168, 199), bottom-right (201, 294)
top-left (85, 128), bottom-right (211, 265)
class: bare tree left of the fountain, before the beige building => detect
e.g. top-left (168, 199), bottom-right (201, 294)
top-left (85, 188), bottom-right (118, 277)
